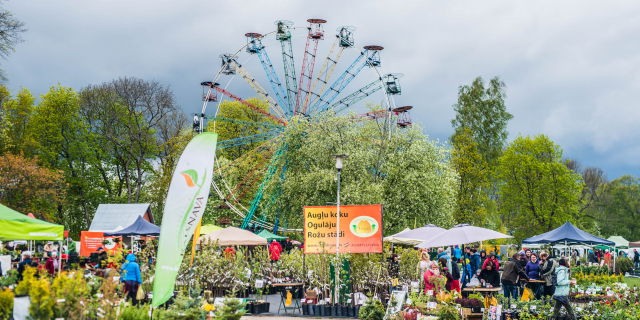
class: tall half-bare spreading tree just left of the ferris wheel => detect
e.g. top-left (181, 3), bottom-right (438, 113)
top-left (80, 77), bottom-right (185, 203)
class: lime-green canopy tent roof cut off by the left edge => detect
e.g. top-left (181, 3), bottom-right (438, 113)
top-left (0, 204), bottom-right (64, 241)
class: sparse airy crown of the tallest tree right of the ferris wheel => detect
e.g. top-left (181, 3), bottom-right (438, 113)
top-left (450, 77), bottom-right (513, 166)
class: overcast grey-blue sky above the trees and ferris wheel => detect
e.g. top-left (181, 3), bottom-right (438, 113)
top-left (5, 0), bottom-right (640, 179)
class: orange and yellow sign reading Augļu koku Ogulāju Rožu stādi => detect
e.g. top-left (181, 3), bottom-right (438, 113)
top-left (304, 204), bottom-right (382, 254)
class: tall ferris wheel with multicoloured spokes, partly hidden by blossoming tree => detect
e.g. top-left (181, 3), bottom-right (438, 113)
top-left (193, 19), bottom-right (412, 233)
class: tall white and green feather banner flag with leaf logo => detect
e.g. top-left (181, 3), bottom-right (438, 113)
top-left (152, 132), bottom-right (218, 307)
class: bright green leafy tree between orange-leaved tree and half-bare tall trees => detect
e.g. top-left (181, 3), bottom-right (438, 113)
top-left (30, 84), bottom-right (106, 234)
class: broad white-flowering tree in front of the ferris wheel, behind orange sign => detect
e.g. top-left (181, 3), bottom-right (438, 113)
top-left (262, 106), bottom-right (458, 235)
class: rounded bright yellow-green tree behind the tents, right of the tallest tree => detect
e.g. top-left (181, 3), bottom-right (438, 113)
top-left (497, 135), bottom-right (582, 241)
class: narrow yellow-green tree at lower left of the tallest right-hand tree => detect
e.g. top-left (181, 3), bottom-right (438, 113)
top-left (451, 127), bottom-right (489, 225)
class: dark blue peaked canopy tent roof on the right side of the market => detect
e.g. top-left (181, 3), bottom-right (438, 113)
top-left (522, 221), bottom-right (615, 246)
